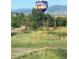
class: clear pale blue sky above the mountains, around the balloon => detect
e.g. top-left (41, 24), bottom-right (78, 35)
top-left (11, 0), bottom-right (67, 10)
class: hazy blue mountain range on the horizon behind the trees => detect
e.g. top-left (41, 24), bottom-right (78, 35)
top-left (11, 5), bottom-right (67, 14)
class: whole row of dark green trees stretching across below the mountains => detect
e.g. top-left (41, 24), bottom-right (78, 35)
top-left (11, 9), bottom-right (67, 29)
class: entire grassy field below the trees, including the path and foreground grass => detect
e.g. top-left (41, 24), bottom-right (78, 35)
top-left (11, 27), bottom-right (67, 59)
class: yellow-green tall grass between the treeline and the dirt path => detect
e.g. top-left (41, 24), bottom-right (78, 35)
top-left (12, 27), bottom-right (67, 48)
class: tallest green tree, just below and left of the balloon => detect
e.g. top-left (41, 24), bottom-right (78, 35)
top-left (29, 9), bottom-right (44, 29)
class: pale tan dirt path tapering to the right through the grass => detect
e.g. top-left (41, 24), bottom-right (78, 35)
top-left (11, 47), bottom-right (65, 59)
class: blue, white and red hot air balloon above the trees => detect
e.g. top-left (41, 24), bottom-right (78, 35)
top-left (34, 0), bottom-right (48, 13)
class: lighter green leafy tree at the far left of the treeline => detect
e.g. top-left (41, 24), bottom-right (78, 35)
top-left (11, 13), bottom-right (27, 27)
